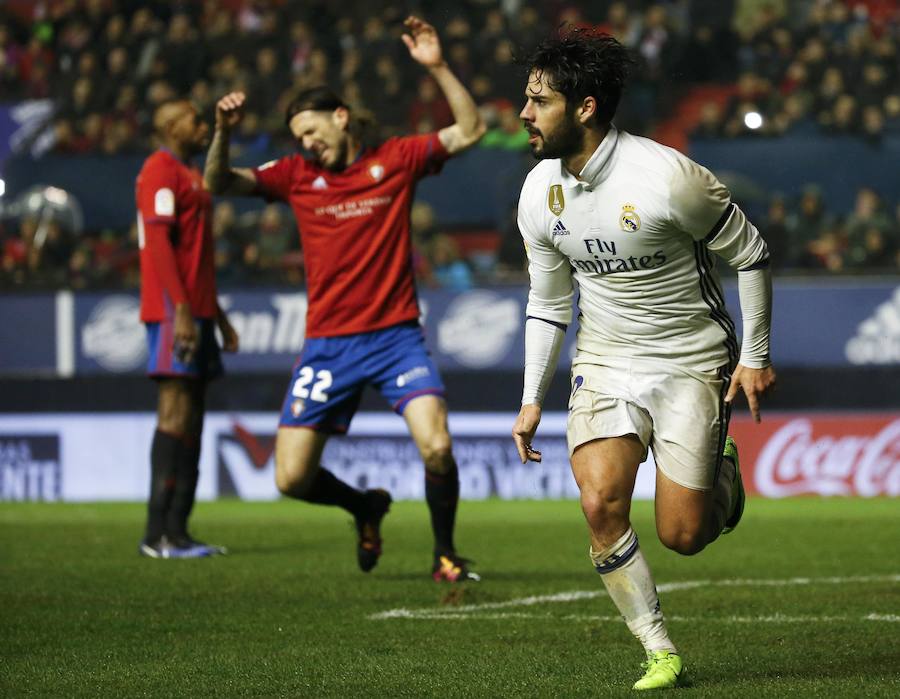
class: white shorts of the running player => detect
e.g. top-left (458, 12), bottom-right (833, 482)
top-left (566, 357), bottom-right (731, 490)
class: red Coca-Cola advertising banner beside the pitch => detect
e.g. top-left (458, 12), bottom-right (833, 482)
top-left (729, 413), bottom-right (900, 498)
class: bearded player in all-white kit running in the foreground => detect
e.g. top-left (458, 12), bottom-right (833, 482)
top-left (513, 29), bottom-right (775, 689)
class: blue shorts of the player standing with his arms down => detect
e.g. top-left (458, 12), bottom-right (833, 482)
top-left (146, 318), bottom-right (224, 381)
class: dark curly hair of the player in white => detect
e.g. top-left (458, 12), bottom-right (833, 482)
top-left (519, 27), bottom-right (634, 124)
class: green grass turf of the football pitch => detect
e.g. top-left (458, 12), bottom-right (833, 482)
top-left (0, 499), bottom-right (900, 698)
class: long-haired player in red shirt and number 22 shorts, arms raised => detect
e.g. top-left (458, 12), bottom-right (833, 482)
top-left (204, 17), bottom-right (484, 582)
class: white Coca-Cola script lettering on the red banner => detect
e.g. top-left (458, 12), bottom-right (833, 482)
top-left (755, 419), bottom-right (900, 498)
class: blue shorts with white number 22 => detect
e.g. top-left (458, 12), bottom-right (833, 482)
top-left (279, 323), bottom-right (444, 433)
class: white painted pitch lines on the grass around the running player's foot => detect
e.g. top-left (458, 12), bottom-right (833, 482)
top-left (368, 575), bottom-right (900, 623)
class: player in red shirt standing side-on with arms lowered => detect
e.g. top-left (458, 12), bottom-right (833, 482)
top-left (136, 100), bottom-right (238, 558)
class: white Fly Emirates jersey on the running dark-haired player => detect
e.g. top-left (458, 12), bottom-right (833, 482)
top-left (519, 127), bottom-right (768, 371)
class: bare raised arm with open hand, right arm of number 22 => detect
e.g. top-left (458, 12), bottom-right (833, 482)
top-left (403, 16), bottom-right (486, 155)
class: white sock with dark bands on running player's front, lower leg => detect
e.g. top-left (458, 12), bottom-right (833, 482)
top-left (591, 527), bottom-right (676, 653)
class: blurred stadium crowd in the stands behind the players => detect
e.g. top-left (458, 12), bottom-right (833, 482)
top-left (0, 0), bottom-right (900, 288)
